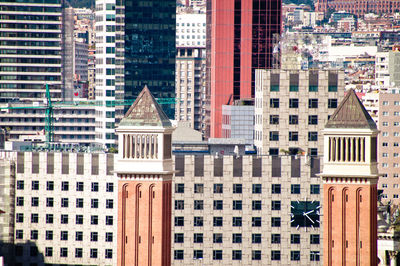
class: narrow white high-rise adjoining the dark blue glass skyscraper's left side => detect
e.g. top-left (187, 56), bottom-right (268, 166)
top-left (95, 0), bottom-right (124, 147)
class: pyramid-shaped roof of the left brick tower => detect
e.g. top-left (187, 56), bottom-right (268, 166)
top-left (119, 86), bottom-right (172, 127)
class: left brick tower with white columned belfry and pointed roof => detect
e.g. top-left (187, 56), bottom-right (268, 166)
top-left (115, 87), bottom-right (173, 266)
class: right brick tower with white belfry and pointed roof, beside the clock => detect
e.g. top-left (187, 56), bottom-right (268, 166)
top-left (321, 90), bottom-right (378, 266)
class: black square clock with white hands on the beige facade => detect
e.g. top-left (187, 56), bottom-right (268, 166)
top-left (290, 201), bottom-right (321, 229)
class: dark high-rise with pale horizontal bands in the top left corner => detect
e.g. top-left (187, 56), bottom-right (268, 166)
top-left (0, 0), bottom-right (63, 102)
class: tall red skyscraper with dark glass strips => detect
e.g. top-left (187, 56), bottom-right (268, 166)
top-left (207, 0), bottom-right (281, 137)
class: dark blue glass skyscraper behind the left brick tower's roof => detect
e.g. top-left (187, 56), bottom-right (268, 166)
top-left (124, 0), bottom-right (176, 118)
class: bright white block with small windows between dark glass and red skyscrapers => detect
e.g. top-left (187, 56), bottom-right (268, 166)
top-left (176, 13), bottom-right (206, 48)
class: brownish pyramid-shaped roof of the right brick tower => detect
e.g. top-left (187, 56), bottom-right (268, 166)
top-left (325, 89), bottom-right (377, 130)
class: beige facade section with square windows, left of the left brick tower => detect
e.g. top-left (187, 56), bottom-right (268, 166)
top-left (13, 152), bottom-right (118, 265)
